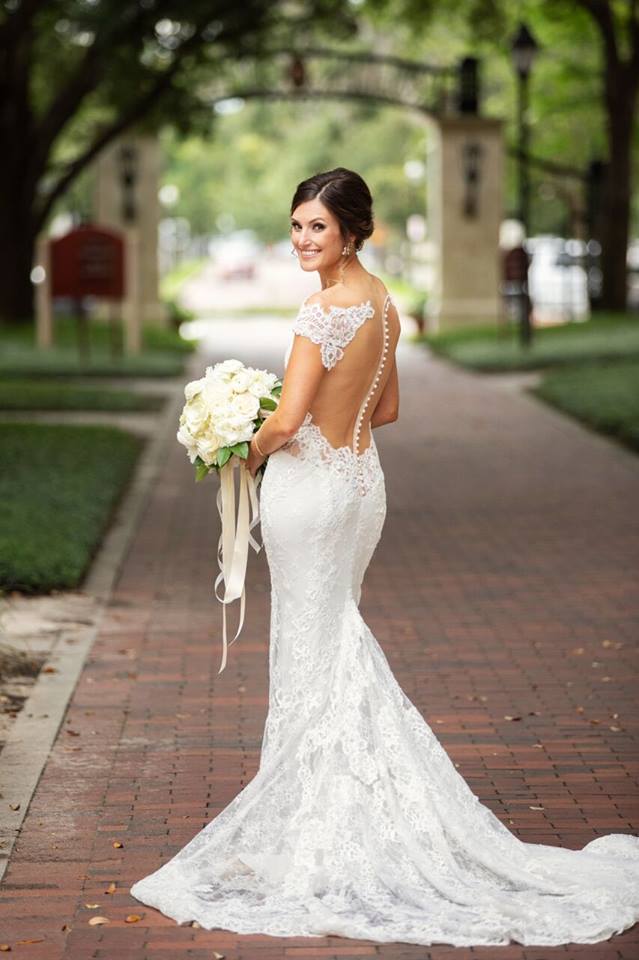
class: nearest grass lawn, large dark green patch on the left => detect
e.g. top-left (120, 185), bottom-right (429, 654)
top-left (0, 423), bottom-right (144, 593)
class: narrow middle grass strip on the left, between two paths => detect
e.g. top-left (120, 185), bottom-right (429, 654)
top-left (0, 377), bottom-right (165, 410)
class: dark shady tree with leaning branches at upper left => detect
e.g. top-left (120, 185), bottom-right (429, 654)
top-left (0, 0), bottom-right (354, 321)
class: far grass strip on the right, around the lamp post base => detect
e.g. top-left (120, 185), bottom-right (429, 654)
top-left (414, 314), bottom-right (639, 372)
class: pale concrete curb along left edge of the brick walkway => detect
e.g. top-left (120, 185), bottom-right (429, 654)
top-left (0, 350), bottom-right (201, 881)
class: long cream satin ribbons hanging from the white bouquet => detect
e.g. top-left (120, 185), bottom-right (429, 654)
top-left (215, 454), bottom-right (262, 674)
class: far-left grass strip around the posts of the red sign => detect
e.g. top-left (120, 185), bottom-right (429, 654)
top-left (0, 316), bottom-right (195, 378)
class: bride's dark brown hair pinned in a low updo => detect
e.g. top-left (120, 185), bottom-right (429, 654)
top-left (291, 167), bottom-right (375, 250)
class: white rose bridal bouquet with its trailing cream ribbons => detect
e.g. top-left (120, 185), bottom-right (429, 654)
top-left (177, 359), bottom-right (282, 674)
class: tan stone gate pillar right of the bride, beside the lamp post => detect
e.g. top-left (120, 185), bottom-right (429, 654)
top-left (425, 114), bottom-right (504, 332)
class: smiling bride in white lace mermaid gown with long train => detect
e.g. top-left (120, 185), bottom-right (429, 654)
top-left (131, 167), bottom-right (639, 946)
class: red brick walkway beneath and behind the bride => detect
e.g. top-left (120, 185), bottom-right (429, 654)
top-left (0, 322), bottom-right (639, 960)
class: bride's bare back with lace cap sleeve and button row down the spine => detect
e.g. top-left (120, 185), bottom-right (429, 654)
top-left (293, 275), bottom-right (400, 453)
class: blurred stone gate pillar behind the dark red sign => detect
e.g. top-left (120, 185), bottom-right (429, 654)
top-left (94, 133), bottom-right (168, 326)
